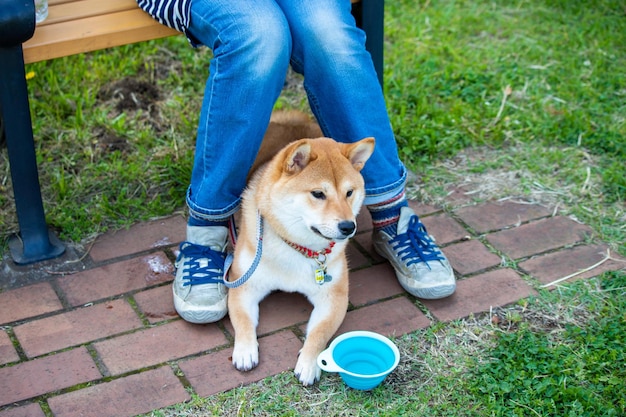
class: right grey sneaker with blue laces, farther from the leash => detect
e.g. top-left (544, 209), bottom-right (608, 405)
top-left (372, 207), bottom-right (456, 300)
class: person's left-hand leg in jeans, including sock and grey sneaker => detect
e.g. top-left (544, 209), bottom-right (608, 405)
top-left (173, 0), bottom-right (291, 323)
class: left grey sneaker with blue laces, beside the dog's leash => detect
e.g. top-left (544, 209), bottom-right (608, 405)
top-left (172, 226), bottom-right (228, 324)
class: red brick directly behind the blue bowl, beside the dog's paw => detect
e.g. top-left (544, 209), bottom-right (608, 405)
top-left (337, 297), bottom-right (430, 337)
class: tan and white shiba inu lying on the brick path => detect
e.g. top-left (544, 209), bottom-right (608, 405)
top-left (228, 113), bottom-right (374, 385)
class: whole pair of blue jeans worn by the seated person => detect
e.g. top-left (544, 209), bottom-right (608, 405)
top-left (187, 0), bottom-right (406, 220)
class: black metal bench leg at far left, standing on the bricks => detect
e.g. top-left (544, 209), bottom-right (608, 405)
top-left (0, 45), bottom-right (65, 264)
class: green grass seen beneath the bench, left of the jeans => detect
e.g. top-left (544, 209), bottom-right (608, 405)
top-left (0, 38), bottom-right (210, 242)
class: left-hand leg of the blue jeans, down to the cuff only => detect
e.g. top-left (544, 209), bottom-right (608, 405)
top-left (187, 0), bottom-right (291, 220)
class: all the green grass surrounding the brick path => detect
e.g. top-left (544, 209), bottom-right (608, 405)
top-left (0, 0), bottom-right (626, 416)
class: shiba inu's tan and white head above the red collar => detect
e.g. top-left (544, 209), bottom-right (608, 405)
top-left (259, 138), bottom-right (374, 245)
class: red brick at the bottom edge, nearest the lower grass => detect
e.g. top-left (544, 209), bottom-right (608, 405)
top-left (48, 366), bottom-right (190, 417)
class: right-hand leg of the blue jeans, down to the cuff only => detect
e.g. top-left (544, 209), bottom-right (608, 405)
top-left (277, 0), bottom-right (406, 205)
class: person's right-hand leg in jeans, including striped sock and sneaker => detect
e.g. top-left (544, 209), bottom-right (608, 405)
top-left (277, 0), bottom-right (456, 298)
